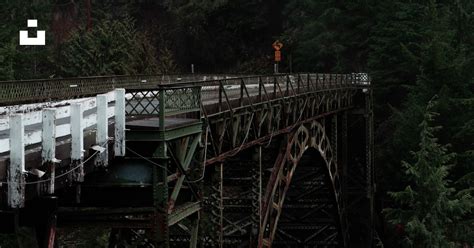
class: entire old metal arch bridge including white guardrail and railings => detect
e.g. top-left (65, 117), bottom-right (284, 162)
top-left (0, 73), bottom-right (375, 247)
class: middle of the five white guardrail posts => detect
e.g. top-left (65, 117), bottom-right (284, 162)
top-left (71, 103), bottom-right (84, 182)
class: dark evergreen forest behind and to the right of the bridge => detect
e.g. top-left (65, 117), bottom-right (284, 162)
top-left (0, 0), bottom-right (474, 247)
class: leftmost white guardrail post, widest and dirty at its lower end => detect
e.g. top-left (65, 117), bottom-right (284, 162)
top-left (8, 114), bottom-right (25, 208)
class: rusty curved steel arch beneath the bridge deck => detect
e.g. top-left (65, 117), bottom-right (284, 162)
top-left (258, 121), bottom-right (348, 247)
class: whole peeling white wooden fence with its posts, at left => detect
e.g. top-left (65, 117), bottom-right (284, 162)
top-left (0, 89), bottom-right (125, 208)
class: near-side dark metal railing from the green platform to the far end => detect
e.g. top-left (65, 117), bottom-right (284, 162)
top-left (156, 73), bottom-right (370, 114)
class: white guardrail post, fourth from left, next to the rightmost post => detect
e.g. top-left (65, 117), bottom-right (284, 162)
top-left (94, 94), bottom-right (109, 166)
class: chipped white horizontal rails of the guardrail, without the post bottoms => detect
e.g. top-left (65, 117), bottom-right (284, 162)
top-left (0, 89), bottom-right (125, 154)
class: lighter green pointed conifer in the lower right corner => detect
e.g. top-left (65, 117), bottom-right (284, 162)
top-left (384, 101), bottom-right (474, 248)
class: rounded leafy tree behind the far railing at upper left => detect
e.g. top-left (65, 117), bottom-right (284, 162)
top-left (55, 17), bottom-right (157, 77)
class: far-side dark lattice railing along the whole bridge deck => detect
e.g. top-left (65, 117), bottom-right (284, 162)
top-left (0, 73), bottom-right (370, 106)
